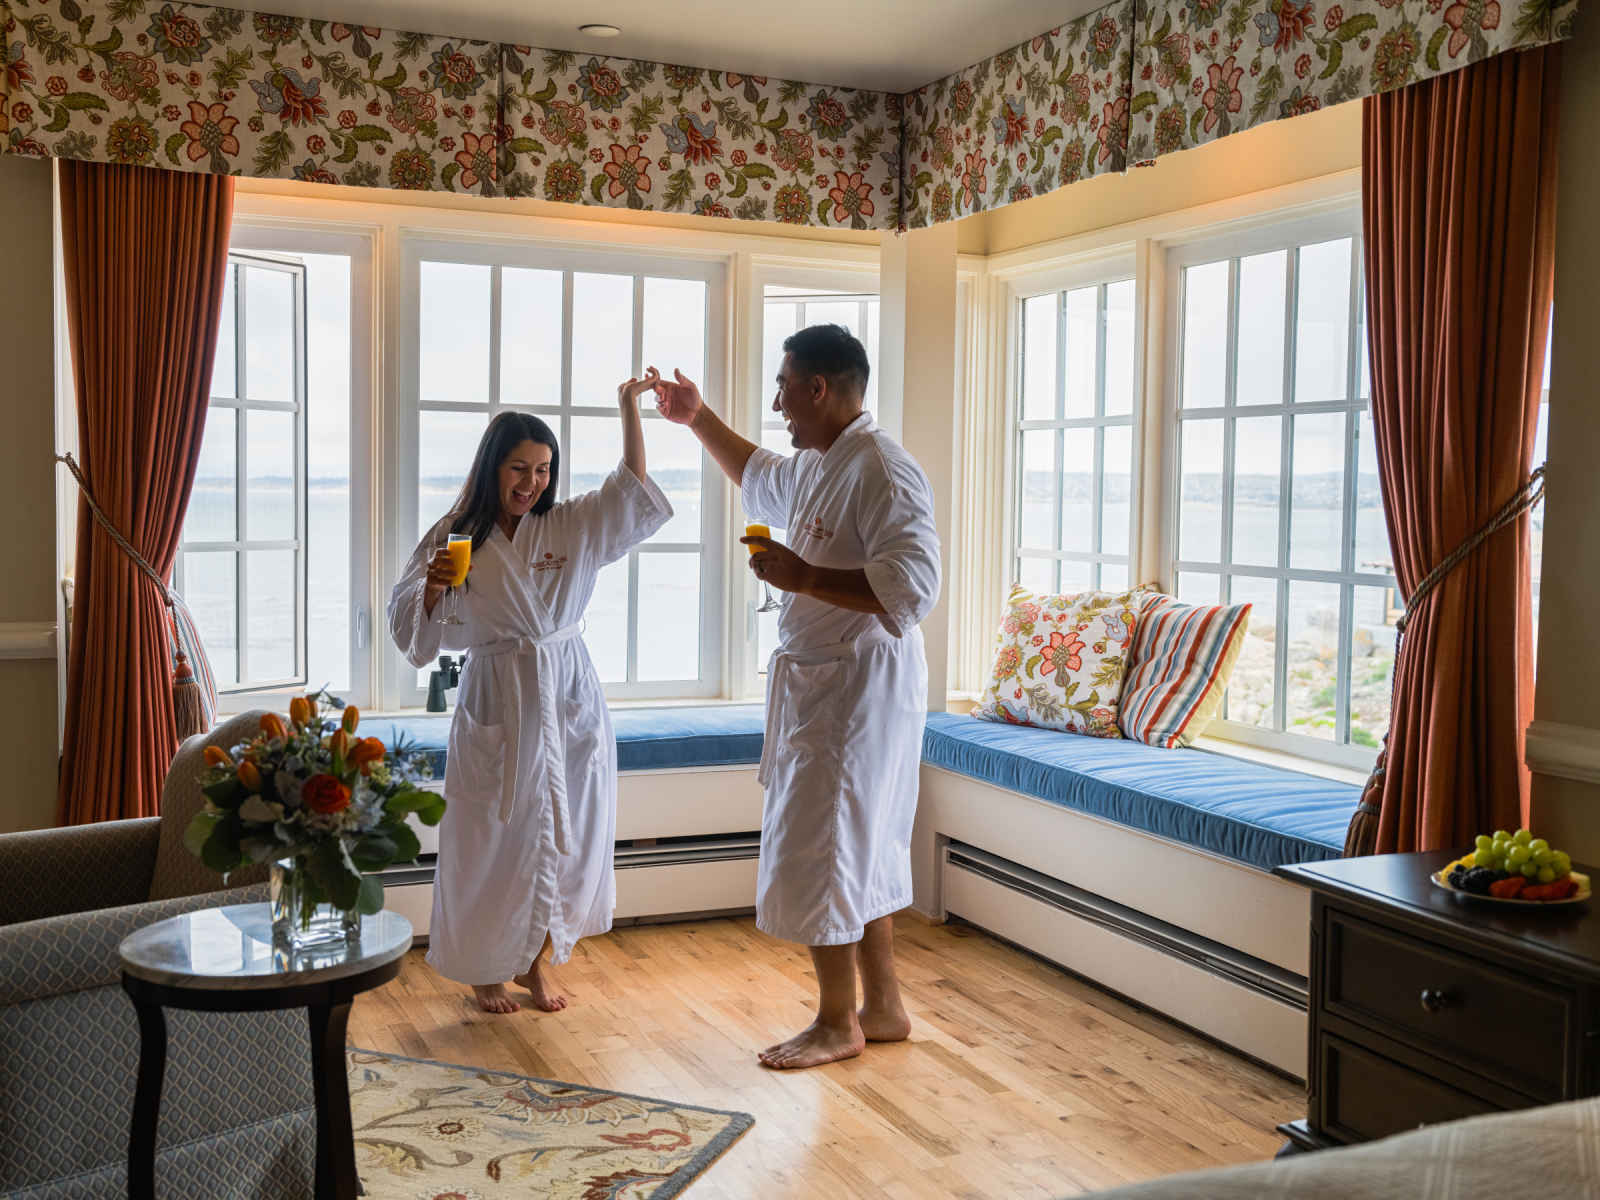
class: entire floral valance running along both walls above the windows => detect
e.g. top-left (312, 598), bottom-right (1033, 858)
top-left (0, 0), bottom-right (1578, 230)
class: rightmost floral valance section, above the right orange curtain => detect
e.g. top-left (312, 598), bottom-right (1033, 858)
top-left (1128, 0), bottom-right (1578, 162)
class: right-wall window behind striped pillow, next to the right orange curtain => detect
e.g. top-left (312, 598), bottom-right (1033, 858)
top-left (1168, 216), bottom-right (1402, 763)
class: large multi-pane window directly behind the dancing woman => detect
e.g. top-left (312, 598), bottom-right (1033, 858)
top-left (400, 242), bottom-right (726, 704)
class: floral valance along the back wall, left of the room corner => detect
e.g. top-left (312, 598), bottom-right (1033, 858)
top-left (0, 0), bottom-right (899, 229)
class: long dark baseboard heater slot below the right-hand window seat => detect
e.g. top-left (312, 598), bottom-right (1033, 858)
top-left (946, 842), bottom-right (1309, 1011)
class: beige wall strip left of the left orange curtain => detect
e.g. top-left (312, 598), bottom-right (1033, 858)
top-left (0, 155), bottom-right (56, 832)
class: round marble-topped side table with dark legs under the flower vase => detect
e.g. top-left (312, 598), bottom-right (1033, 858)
top-left (117, 902), bottom-right (411, 1200)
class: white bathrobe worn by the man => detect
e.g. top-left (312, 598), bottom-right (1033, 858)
top-left (742, 413), bottom-right (939, 946)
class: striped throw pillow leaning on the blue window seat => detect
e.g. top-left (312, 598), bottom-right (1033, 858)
top-left (1118, 594), bottom-right (1250, 749)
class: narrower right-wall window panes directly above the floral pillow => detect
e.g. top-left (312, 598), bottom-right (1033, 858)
top-left (1011, 278), bottom-right (1136, 592)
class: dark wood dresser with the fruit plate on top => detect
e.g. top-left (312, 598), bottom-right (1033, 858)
top-left (1275, 851), bottom-right (1600, 1150)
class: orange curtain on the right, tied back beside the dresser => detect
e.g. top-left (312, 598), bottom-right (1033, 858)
top-left (1362, 46), bottom-right (1560, 853)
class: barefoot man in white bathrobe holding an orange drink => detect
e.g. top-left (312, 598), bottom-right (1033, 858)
top-left (656, 325), bottom-right (939, 1067)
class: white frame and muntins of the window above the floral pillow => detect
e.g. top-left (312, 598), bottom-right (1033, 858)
top-left (997, 259), bottom-right (1149, 598)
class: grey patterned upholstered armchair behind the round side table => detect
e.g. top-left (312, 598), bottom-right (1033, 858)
top-left (0, 712), bottom-right (317, 1200)
